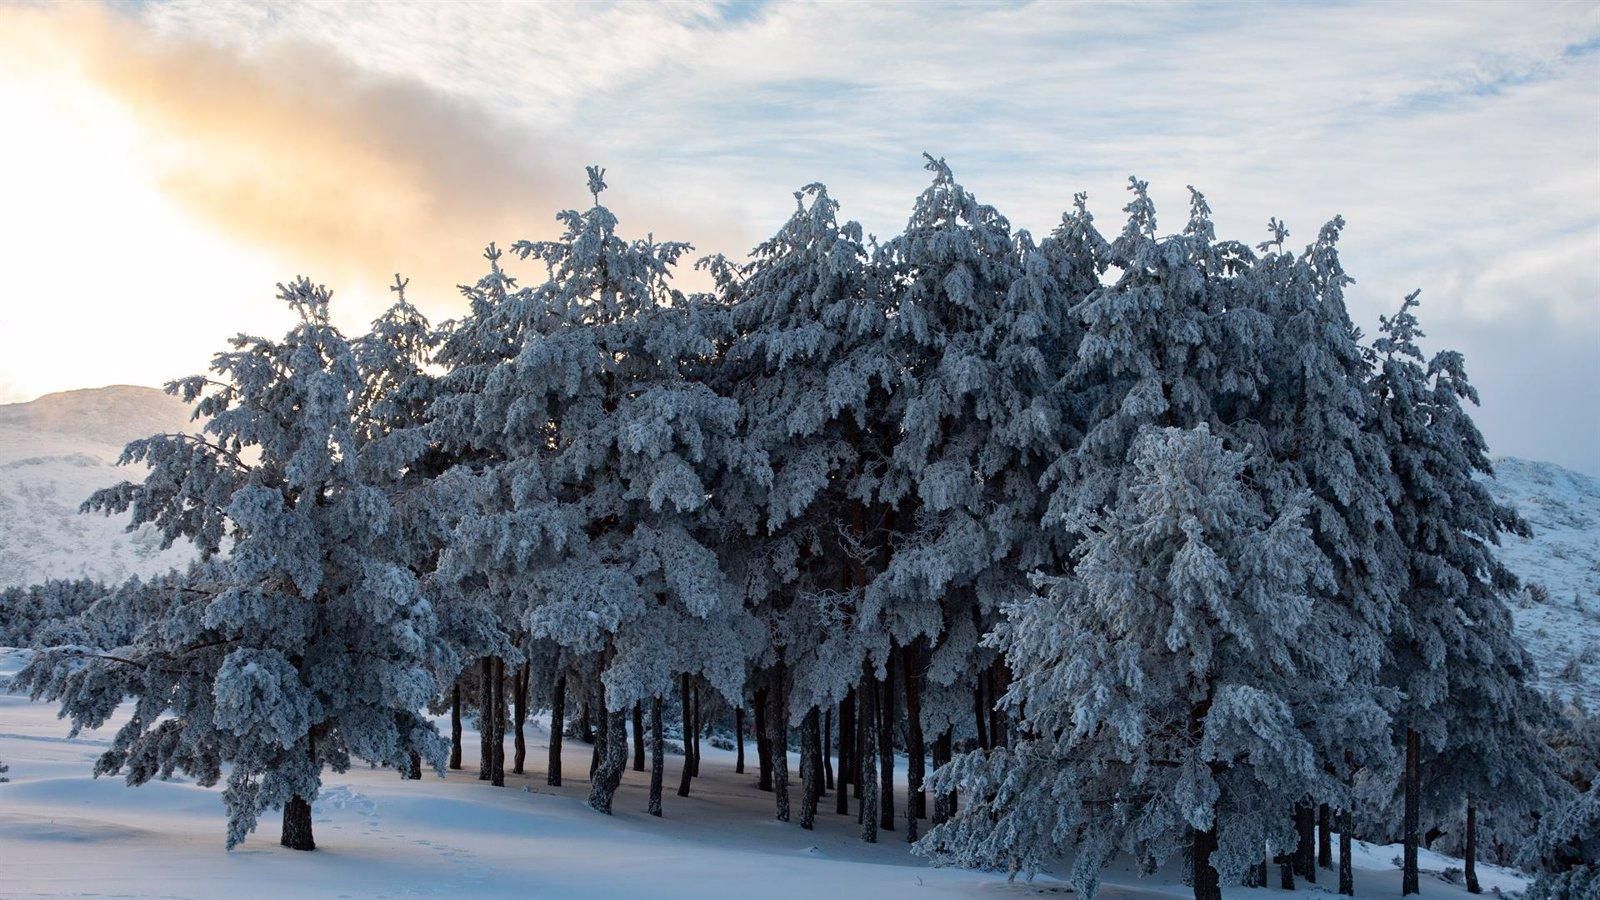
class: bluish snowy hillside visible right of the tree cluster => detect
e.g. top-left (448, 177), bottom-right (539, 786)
top-left (1490, 456), bottom-right (1600, 709)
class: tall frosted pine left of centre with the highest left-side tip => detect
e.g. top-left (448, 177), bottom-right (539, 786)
top-left (440, 168), bottom-right (757, 812)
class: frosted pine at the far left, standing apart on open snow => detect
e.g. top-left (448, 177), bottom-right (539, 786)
top-left (18, 279), bottom-right (451, 850)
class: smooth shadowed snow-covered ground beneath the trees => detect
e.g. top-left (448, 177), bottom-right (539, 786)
top-left (0, 652), bottom-right (1525, 900)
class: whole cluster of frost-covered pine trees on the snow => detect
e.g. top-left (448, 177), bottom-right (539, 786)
top-left (6, 159), bottom-right (1592, 898)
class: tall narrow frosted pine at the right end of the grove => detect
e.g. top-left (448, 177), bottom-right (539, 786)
top-left (1373, 291), bottom-right (1541, 894)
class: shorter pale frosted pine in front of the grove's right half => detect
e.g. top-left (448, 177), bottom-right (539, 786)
top-left (918, 424), bottom-right (1326, 900)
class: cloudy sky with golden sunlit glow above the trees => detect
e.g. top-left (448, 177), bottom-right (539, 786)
top-left (0, 0), bottom-right (1600, 476)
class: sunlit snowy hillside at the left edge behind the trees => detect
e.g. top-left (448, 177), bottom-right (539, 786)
top-left (0, 384), bottom-right (192, 588)
